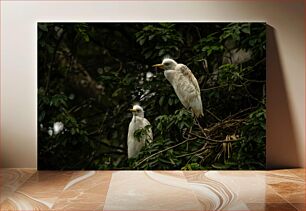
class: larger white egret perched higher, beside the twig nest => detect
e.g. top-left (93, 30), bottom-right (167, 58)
top-left (153, 58), bottom-right (203, 117)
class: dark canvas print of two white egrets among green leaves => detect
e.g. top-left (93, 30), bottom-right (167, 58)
top-left (37, 22), bottom-right (266, 170)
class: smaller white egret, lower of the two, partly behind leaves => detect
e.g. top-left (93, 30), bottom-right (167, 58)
top-left (127, 105), bottom-right (153, 158)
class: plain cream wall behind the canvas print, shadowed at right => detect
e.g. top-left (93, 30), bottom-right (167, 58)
top-left (0, 0), bottom-right (305, 167)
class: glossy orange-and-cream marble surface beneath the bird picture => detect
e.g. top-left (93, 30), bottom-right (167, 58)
top-left (0, 169), bottom-right (306, 211)
